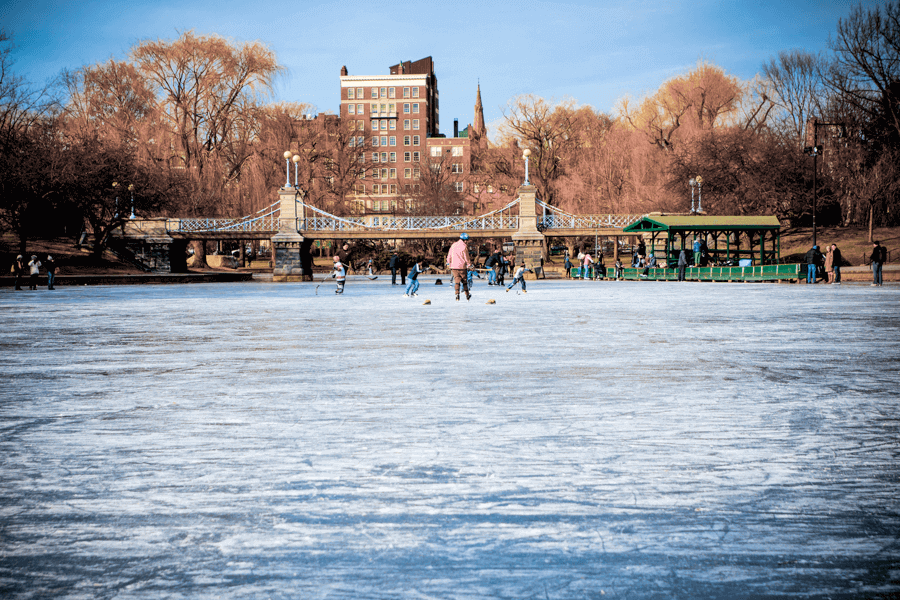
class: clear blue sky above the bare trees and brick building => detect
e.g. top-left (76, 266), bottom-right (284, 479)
top-left (0, 0), bottom-right (884, 133)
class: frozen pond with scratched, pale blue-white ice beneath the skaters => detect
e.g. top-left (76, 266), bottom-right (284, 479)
top-left (0, 277), bottom-right (900, 599)
